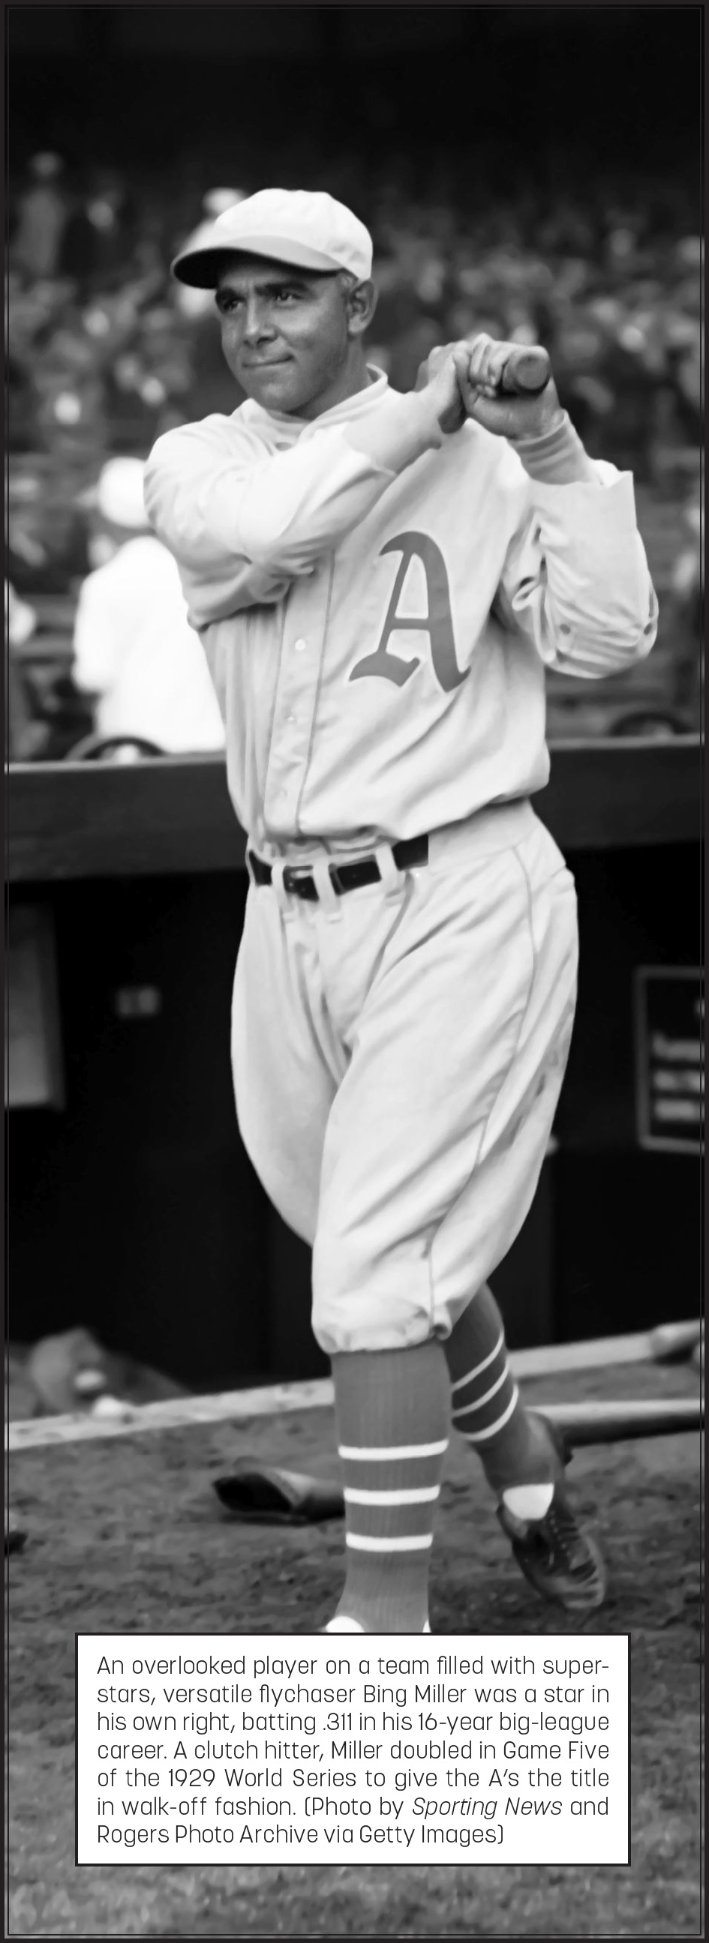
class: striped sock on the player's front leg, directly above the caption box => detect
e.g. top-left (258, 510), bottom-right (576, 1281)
top-left (332, 1341), bottom-right (451, 1632)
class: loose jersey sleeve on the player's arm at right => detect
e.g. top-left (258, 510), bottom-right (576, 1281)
top-left (499, 427), bottom-right (658, 680)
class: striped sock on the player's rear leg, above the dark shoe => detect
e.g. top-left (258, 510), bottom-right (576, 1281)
top-left (443, 1282), bottom-right (559, 1517)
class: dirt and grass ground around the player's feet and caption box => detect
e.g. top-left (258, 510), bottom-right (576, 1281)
top-left (8, 1366), bottom-right (703, 1937)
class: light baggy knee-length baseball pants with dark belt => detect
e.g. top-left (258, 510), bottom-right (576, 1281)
top-left (233, 802), bottom-right (577, 1354)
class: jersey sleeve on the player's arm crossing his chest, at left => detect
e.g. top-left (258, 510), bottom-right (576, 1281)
top-left (146, 396), bottom-right (441, 620)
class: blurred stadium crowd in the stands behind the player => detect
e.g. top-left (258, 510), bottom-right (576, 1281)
top-left (8, 153), bottom-right (701, 760)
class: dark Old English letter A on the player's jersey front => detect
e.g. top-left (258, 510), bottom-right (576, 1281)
top-left (350, 532), bottom-right (468, 694)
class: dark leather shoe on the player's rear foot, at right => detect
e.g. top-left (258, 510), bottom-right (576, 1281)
top-left (497, 1413), bottom-right (608, 1615)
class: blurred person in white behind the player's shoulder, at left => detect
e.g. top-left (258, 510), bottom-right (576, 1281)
top-left (74, 459), bottom-right (223, 754)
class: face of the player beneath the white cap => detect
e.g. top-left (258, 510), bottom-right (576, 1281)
top-left (216, 256), bottom-right (357, 418)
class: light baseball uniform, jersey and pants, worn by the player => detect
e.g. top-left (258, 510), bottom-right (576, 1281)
top-left (146, 373), bottom-right (657, 1354)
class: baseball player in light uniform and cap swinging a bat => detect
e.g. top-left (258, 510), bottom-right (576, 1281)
top-left (146, 188), bottom-right (657, 1632)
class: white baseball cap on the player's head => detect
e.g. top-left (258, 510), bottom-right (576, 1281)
top-left (173, 188), bottom-right (373, 290)
